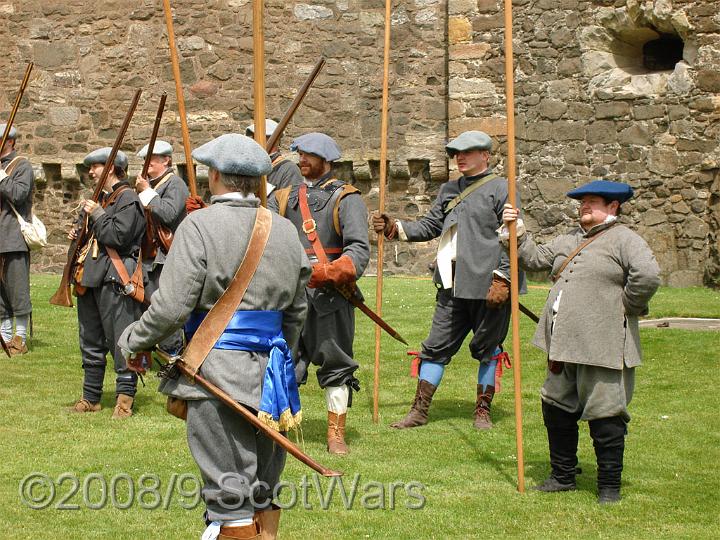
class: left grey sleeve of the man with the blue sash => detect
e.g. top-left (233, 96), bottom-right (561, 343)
top-left (119, 219), bottom-right (207, 352)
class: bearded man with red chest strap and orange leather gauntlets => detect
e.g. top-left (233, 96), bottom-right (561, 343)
top-left (269, 133), bottom-right (370, 455)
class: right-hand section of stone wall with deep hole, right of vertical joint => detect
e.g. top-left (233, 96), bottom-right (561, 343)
top-left (448, 0), bottom-right (720, 286)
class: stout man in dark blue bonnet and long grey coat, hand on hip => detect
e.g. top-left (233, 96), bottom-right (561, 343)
top-left (500, 180), bottom-right (660, 504)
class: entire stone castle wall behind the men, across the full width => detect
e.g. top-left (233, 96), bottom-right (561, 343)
top-left (0, 0), bottom-right (720, 285)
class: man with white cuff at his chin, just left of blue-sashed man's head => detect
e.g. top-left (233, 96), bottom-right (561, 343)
top-left (135, 139), bottom-right (190, 355)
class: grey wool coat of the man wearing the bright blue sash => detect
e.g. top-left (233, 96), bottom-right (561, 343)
top-left (119, 194), bottom-right (311, 409)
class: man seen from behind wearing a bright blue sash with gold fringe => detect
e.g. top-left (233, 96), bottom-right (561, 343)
top-left (120, 134), bottom-right (311, 539)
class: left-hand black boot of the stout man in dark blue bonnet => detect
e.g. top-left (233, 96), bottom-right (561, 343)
top-left (533, 401), bottom-right (580, 492)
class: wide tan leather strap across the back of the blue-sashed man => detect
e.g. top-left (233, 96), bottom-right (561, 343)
top-left (182, 206), bottom-right (272, 375)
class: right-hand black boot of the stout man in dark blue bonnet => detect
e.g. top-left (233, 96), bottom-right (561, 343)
top-left (589, 416), bottom-right (627, 504)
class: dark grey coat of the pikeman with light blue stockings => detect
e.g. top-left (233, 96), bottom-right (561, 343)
top-left (400, 170), bottom-right (525, 300)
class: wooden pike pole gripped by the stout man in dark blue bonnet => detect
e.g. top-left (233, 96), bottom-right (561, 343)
top-left (504, 0), bottom-right (525, 493)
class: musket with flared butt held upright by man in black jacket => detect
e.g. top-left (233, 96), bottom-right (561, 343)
top-left (50, 89), bottom-right (142, 307)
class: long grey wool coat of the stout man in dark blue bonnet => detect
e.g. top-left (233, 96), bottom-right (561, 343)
top-left (518, 220), bottom-right (660, 369)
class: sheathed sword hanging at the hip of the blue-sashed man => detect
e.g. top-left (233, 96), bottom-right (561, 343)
top-left (155, 349), bottom-right (343, 477)
